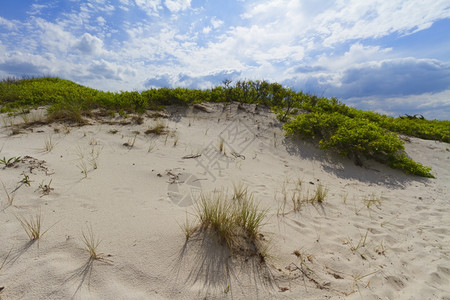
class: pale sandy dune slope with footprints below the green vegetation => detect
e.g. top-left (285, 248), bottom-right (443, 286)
top-left (0, 105), bottom-right (450, 299)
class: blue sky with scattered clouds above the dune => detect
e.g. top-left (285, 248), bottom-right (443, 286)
top-left (0, 0), bottom-right (450, 120)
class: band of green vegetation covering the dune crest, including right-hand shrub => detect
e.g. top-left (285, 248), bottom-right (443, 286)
top-left (0, 77), bottom-right (450, 177)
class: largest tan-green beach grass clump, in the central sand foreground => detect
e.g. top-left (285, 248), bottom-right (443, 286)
top-left (189, 187), bottom-right (267, 255)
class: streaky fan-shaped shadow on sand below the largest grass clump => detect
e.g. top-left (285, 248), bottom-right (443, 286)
top-left (170, 230), bottom-right (278, 298)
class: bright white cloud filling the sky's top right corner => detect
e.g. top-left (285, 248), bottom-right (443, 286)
top-left (313, 0), bottom-right (450, 46)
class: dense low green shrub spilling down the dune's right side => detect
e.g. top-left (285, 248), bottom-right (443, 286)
top-left (283, 112), bottom-right (433, 177)
